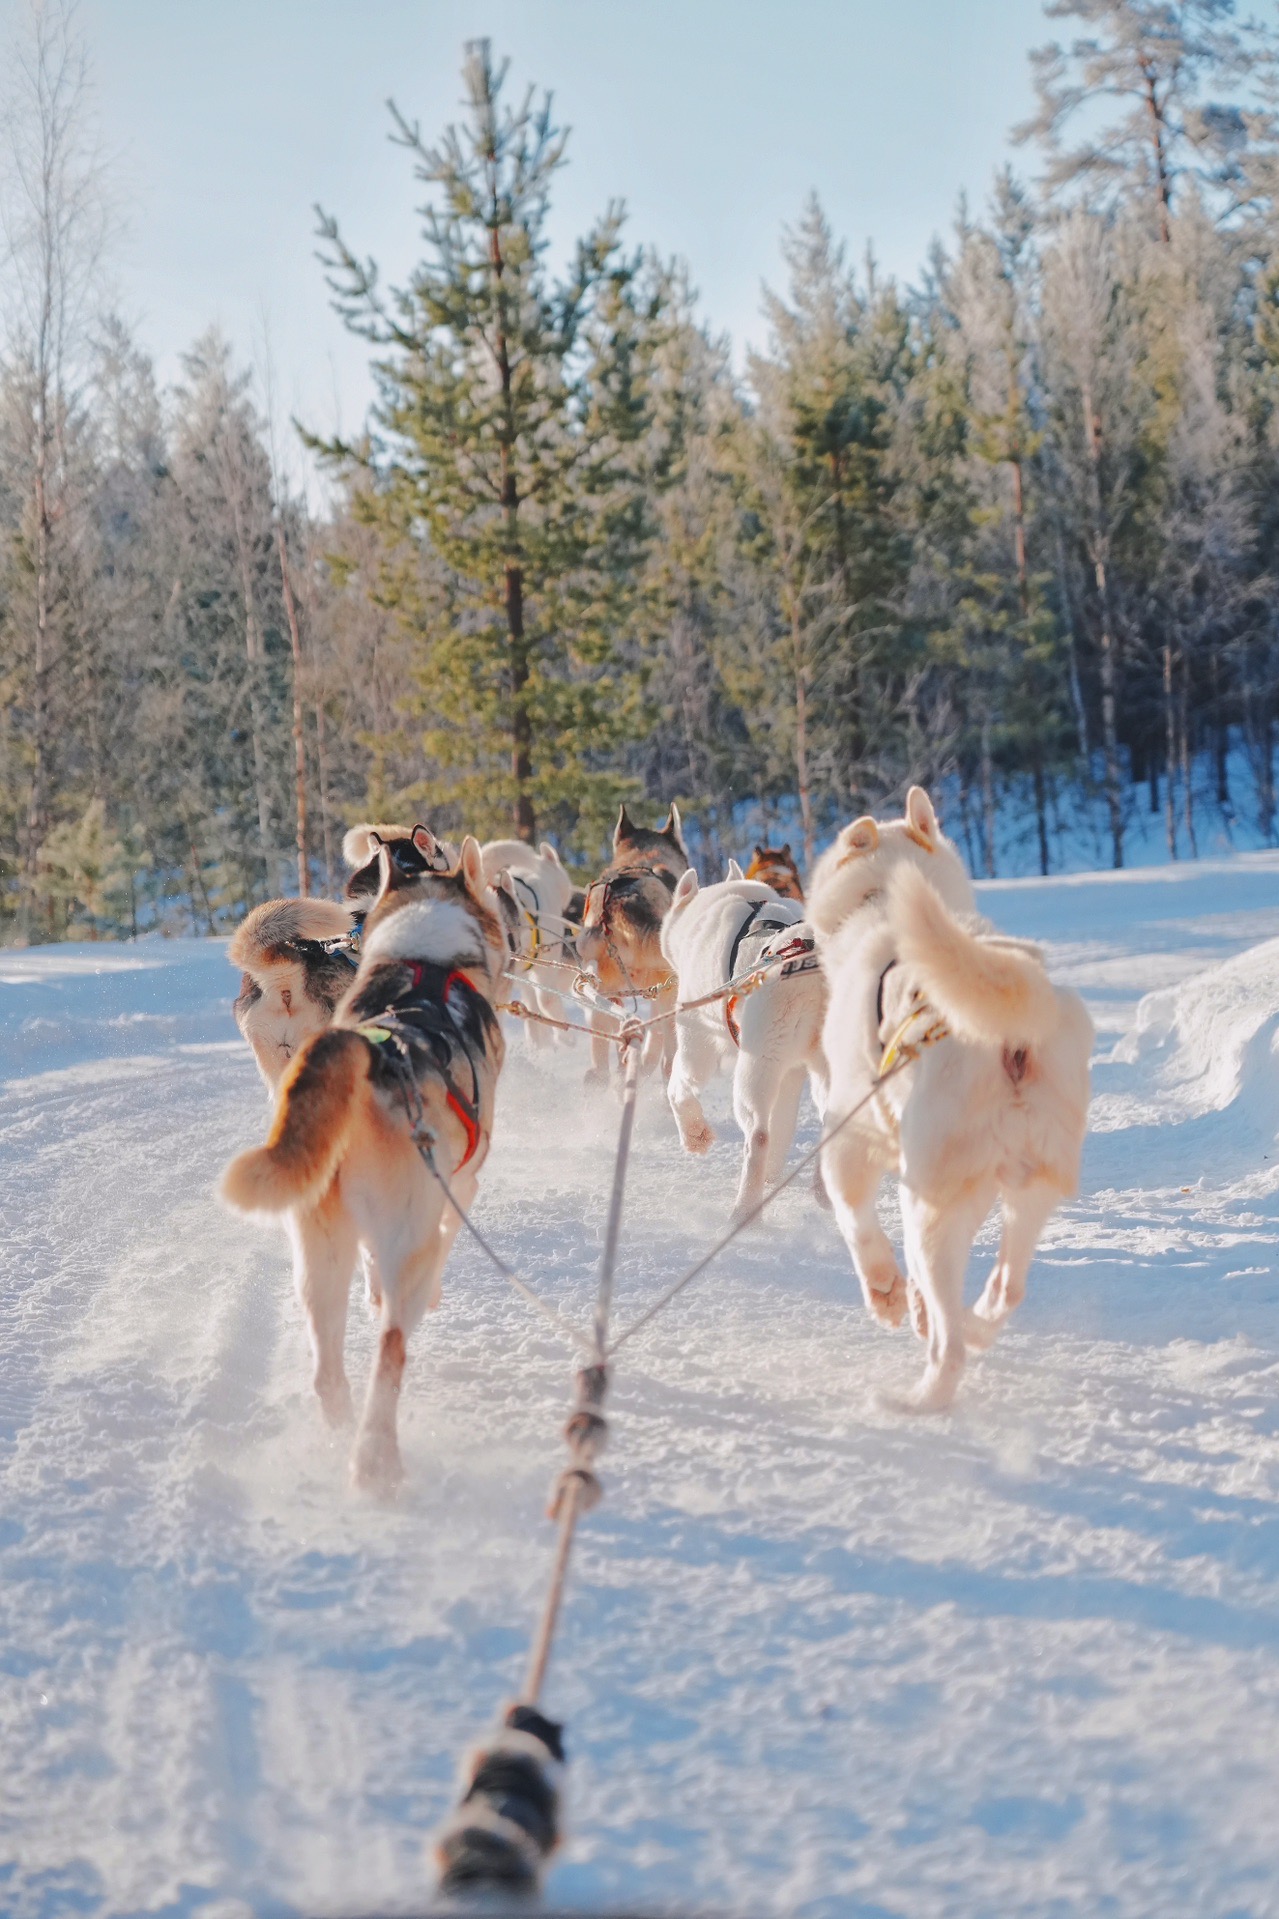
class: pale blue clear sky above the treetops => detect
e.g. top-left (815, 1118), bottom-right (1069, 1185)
top-left (0, 0), bottom-right (1049, 456)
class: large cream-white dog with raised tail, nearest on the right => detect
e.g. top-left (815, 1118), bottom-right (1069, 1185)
top-left (808, 787), bottom-right (1093, 1412)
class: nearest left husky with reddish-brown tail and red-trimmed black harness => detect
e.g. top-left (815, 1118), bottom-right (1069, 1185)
top-left (221, 839), bottom-right (505, 1491)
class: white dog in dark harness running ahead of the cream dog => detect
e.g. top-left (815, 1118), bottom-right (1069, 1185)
top-left (661, 860), bottom-right (826, 1219)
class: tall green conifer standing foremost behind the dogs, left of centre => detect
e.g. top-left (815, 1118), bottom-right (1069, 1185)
top-left (321, 40), bottom-right (655, 841)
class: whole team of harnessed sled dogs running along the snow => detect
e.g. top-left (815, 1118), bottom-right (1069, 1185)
top-left (223, 787), bottom-right (1093, 1491)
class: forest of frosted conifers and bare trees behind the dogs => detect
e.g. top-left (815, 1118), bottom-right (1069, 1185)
top-left (0, 0), bottom-right (1279, 940)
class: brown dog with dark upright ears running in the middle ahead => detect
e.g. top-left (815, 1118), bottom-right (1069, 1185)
top-left (576, 806), bottom-right (689, 1080)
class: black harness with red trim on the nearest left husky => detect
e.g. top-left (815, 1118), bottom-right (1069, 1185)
top-left (351, 960), bottom-right (497, 1173)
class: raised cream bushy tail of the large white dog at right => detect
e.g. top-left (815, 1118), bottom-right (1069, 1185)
top-left (889, 865), bottom-right (1060, 1046)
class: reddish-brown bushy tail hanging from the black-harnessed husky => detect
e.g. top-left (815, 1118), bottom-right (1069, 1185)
top-left (221, 1027), bottom-right (369, 1213)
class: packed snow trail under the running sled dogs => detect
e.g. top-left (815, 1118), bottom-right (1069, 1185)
top-left (0, 854), bottom-right (1279, 1919)
